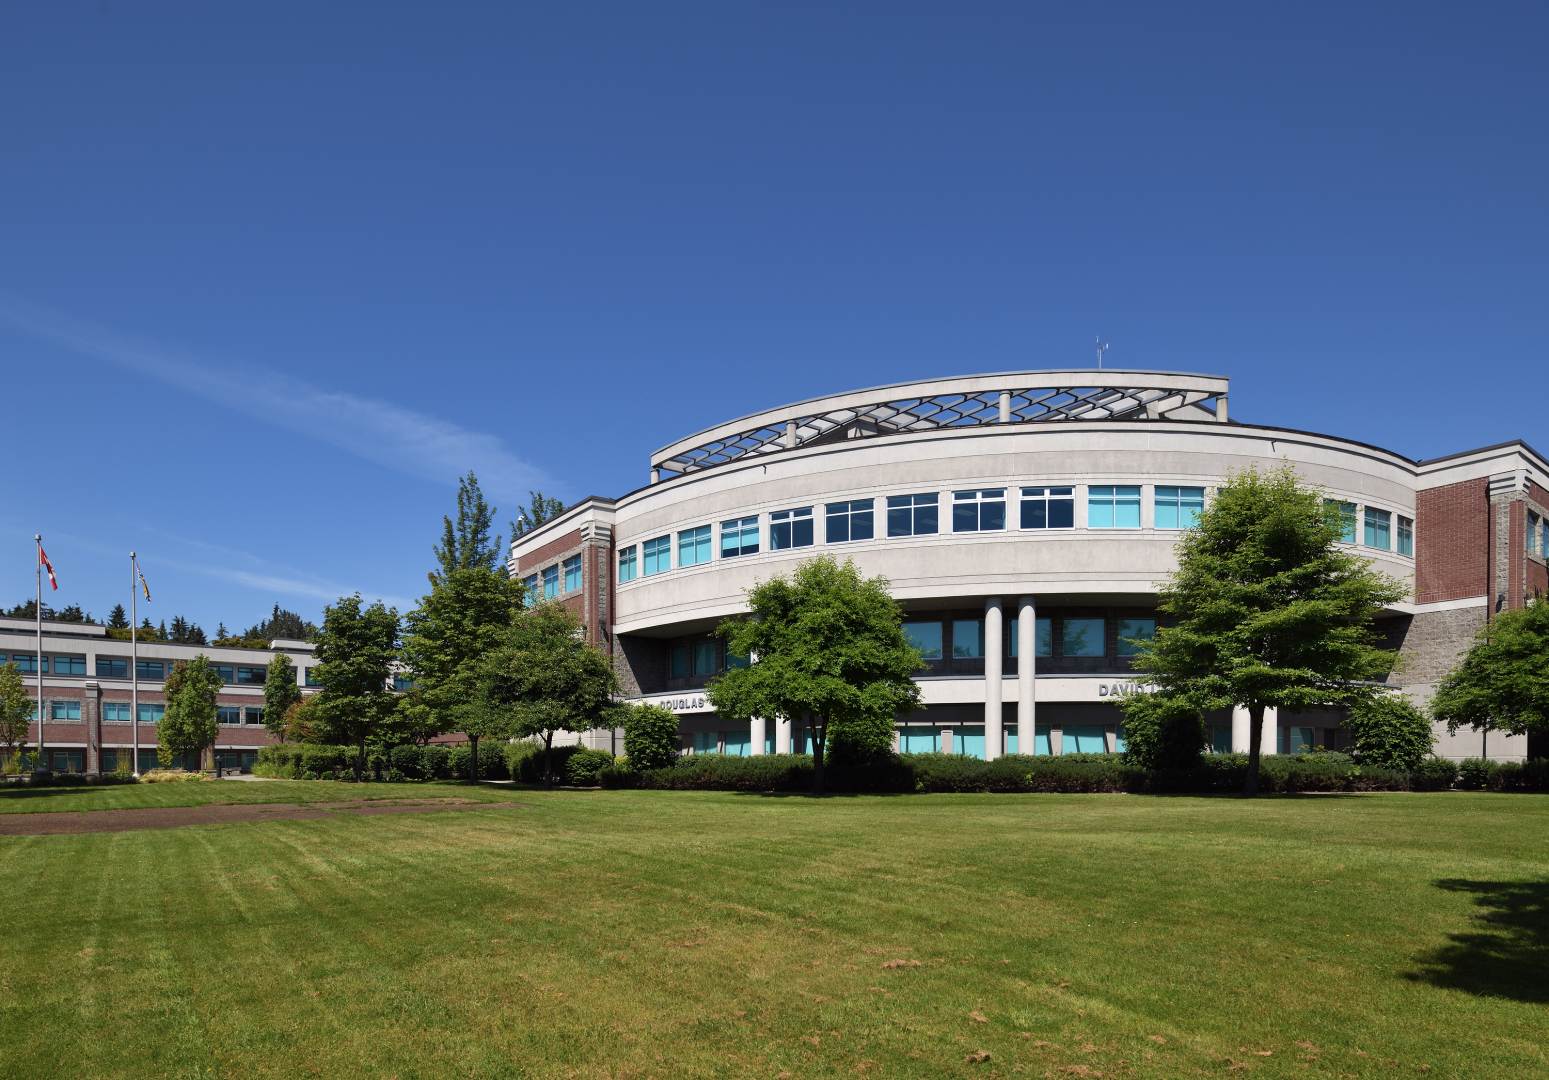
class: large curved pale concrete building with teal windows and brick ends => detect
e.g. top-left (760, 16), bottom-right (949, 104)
top-left (510, 370), bottom-right (1549, 759)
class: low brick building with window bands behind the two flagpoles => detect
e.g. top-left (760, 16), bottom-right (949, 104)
top-left (0, 618), bottom-right (316, 773)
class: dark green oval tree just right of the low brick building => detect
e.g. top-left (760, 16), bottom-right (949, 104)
top-left (314, 593), bottom-right (398, 779)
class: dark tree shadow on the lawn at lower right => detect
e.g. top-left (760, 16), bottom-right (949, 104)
top-left (1408, 877), bottom-right (1549, 1004)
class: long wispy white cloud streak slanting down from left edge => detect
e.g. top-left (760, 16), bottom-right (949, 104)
top-left (0, 291), bottom-right (545, 505)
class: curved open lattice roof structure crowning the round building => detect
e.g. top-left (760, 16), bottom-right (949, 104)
top-left (651, 369), bottom-right (1228, 479)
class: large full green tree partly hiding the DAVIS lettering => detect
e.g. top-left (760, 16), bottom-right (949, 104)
top-left (1134, 466), bottom-right (1405, 795)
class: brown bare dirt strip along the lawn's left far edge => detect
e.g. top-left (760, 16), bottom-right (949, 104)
top-left (0, 798), bottom-right (516, 837)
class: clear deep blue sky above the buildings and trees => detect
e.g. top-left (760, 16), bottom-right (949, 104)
top-left (0, 0), bottom-right (1549, 629)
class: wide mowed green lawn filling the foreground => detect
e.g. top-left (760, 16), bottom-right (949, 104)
top-left (0, 784), bottom-right (1549, 1077)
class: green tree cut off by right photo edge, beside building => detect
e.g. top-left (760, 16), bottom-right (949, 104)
top-left (1431, 600), bottom-right (1549, 734)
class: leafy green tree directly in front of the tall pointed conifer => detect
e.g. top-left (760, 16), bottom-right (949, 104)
top-left (403, 566), bottom-right (524, 781)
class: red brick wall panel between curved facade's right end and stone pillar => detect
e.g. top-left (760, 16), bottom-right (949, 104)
top-left (1414, 479), bottom-right (1490, 604)
